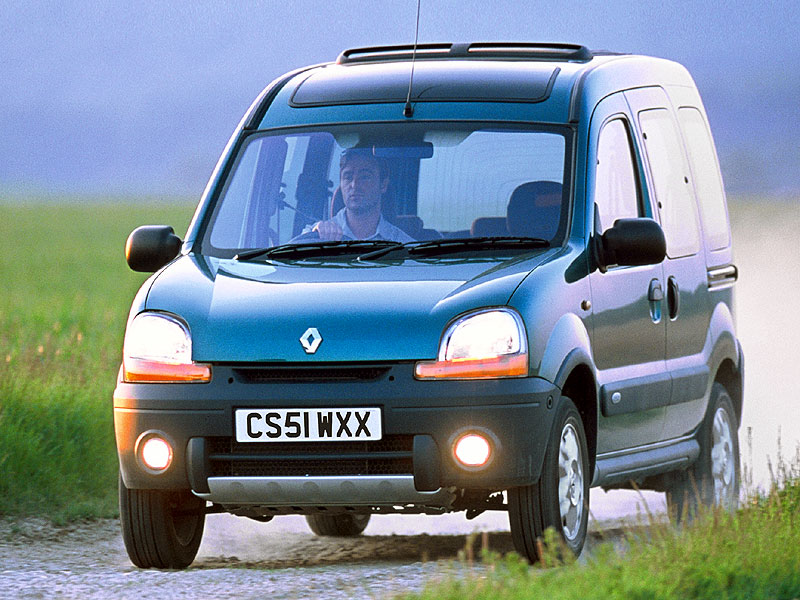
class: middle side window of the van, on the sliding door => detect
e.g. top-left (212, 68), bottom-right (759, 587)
top-left (639, 108), bottom-right (700, 258)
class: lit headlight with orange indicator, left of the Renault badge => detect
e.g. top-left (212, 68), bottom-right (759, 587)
top-left (122, 313), bottom-right (211, 382)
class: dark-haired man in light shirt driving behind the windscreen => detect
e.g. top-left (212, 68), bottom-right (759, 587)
top-left (311, 148), bottom-right (414, 243)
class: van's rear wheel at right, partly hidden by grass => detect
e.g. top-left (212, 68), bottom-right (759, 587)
top-left (667, 383), bottom-right (740, 524)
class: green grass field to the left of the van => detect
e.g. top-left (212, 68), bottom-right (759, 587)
top-left (0, 203), bottom-right (193, 521)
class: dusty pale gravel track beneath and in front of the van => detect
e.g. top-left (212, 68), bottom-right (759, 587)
top-left (0, 491), bottom-right (663, 600)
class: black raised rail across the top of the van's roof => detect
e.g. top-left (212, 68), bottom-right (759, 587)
top-left (336, 42), bottom-right (593, 65)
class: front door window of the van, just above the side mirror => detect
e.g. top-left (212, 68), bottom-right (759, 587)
top-left (594, 119), bottom-right (641, 232)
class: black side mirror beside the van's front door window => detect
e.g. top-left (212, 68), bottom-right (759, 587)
top-left (596, 219), bottom-right (667, 270)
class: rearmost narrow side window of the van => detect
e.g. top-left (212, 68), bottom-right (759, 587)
top-left (678, 107), bottom-right (730, 250)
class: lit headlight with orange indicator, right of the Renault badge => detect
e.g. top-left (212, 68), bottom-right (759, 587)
top-left (414, 308), bottom-right (528, 379)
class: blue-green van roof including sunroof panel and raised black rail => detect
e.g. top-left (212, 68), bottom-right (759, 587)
top-left (250, 42), bottom-right (694, 127)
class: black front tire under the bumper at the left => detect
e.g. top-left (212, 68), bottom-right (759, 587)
top-left (119, 476), bottom-right (206, 569)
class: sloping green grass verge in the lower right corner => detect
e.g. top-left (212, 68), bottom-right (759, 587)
top-left (398, 454), bottom-right (800, 600)
